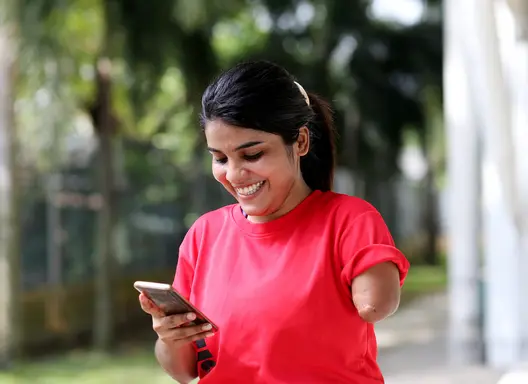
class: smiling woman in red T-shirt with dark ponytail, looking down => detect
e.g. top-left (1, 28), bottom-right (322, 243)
top-left (140, 62), bottom-right (409, 384)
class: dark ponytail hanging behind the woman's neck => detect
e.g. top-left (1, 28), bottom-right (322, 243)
top-left (301, 93), bottom-right (336, 192)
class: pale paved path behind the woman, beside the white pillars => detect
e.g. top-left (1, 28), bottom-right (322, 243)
top-left (376, 294), bottom-right (504, 384)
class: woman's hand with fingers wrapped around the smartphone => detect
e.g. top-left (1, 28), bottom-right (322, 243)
top-left (139, 293), bottom-right (214, 347)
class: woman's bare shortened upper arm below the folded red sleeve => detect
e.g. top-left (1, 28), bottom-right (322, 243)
top-left (351, 261), bottom-right (401, 323)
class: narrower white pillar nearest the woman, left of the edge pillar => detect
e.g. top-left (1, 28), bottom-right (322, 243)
top-left (444, 0), bottom-right (480, 364)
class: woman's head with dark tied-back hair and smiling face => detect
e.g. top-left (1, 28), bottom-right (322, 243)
top-left (201, 62), bottom-right (334, 222)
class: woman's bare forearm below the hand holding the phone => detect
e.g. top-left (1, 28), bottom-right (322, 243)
top-left (155, 339), bottom-right (198, 384)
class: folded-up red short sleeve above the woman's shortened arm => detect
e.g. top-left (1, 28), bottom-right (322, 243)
top-left (339, 209), bottom-right (409, 286)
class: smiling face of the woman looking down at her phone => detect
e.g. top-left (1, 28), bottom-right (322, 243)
top-left (205, 120), bottom-right (309, 221)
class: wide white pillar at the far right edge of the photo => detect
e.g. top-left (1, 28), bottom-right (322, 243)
top-left (471, 0), bottom-right (528, 368)
